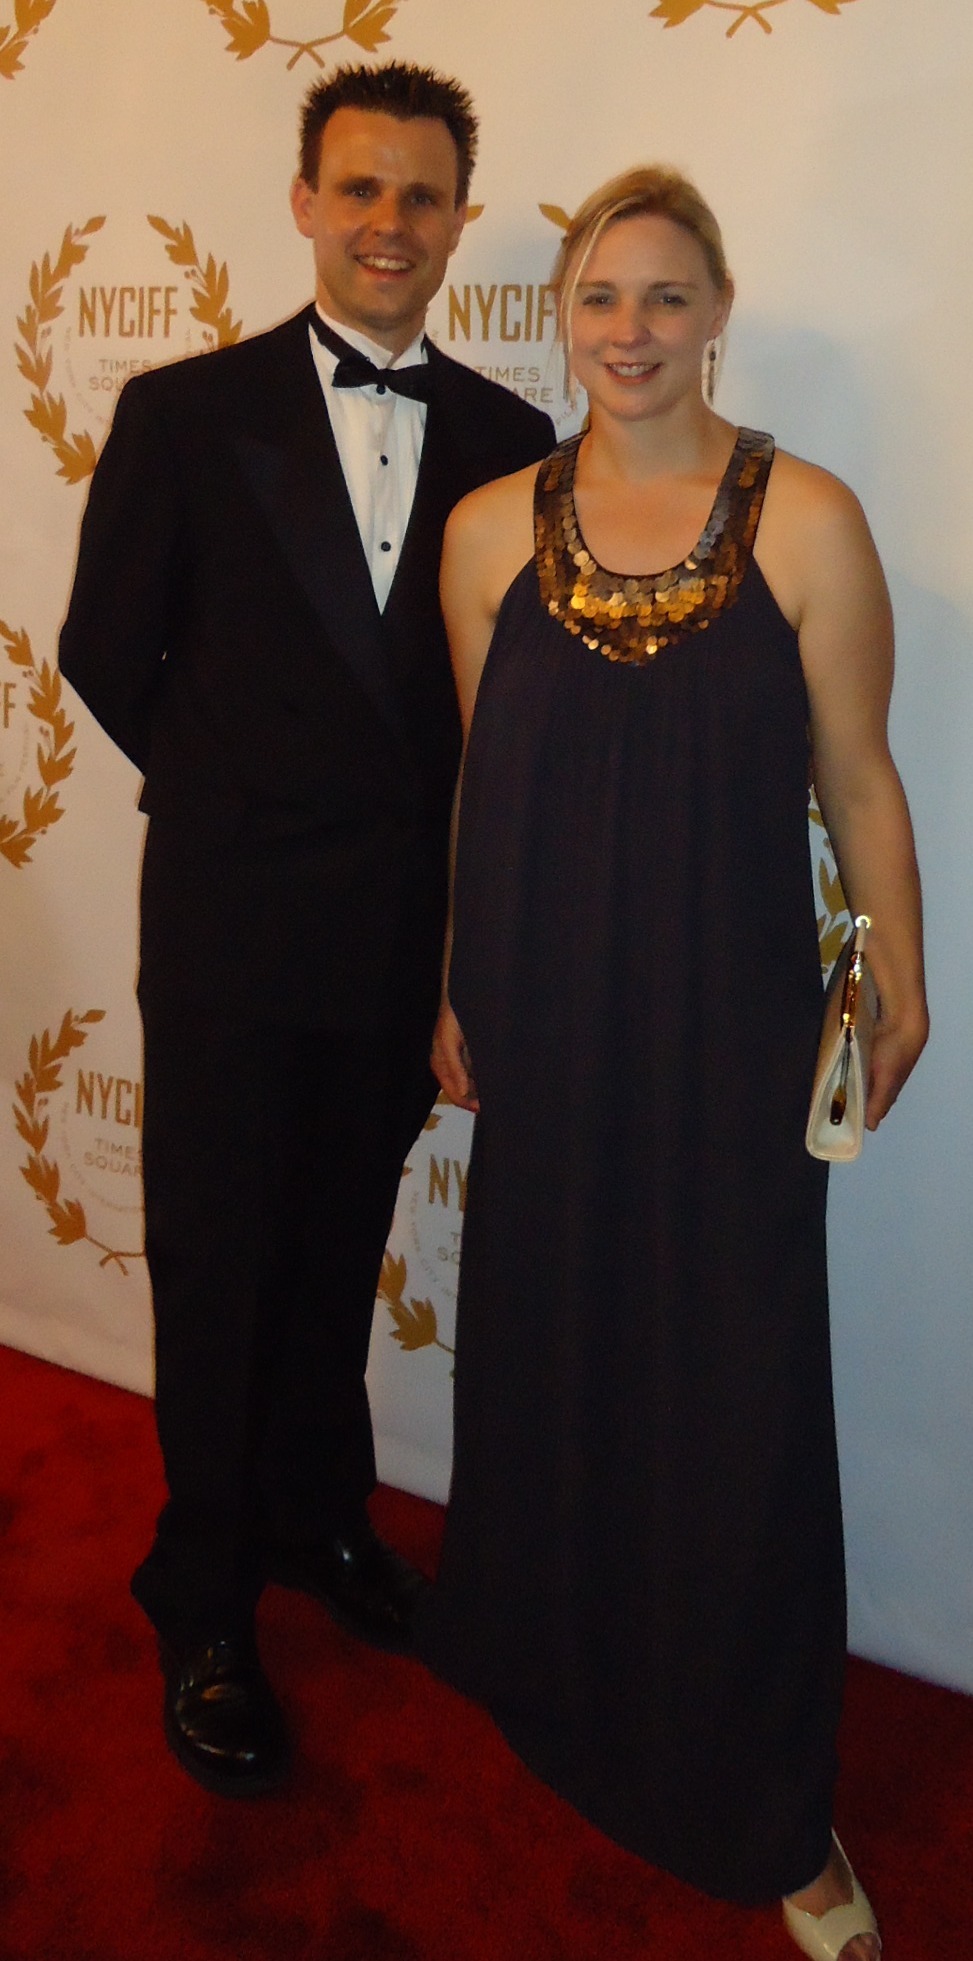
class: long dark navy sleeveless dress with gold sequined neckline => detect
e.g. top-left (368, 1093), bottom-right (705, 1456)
top-left (422, 431), bottom-right (845, 1902)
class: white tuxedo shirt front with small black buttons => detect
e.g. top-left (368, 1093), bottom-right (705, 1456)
top-left (308, 308), bottom-right (426, 612)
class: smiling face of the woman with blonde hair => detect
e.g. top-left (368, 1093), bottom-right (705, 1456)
top-left (571, 214), bottom-right (732, 420)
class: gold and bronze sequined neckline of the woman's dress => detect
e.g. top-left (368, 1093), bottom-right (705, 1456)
top-left (534, 429), bottom-right (773, 667)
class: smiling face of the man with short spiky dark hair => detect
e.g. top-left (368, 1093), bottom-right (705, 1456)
top-left (290, 108), bottom-right (467, 355)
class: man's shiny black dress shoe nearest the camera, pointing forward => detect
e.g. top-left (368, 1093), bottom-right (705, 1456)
top-left (159, 1639), bottom-right (290, 1798)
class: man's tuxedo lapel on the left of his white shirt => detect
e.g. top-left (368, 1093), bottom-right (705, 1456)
top-left (235, 314), bottom-right (404, 735)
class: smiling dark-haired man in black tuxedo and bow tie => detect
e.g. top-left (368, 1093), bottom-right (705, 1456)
top-left (61, 63), bottom-right (553, 1794)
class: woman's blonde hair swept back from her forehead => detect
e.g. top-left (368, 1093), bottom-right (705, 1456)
top-left (551, 163), bottom-right (734, 388)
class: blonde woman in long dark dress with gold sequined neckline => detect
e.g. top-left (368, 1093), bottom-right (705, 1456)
top-left (422, 169), bottom-right (926, 1961)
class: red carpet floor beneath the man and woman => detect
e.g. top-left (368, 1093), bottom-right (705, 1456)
top-left (0, 1349), bottom-right (973, 1961)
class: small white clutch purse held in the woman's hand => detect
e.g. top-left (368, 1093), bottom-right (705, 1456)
top-left (804, 912), bottom-right (879, 1165)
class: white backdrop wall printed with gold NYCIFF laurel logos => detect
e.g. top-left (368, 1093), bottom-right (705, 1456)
top-left (0, 0), bottom-right (973, 1688)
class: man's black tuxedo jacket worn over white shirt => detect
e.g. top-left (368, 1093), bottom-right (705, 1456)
top-left (61, 312), bottom-right (553, 1024)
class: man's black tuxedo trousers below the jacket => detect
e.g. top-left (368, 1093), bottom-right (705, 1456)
top-left (133, 975), bottom-right (435, 1641)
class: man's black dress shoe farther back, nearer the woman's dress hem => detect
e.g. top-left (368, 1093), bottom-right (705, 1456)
top-left (267, 1526), bottom-right (430, 1655)
